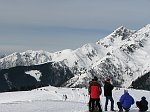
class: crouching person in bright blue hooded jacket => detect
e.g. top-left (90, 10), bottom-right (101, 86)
top-left (117, 90), bottom-right (134, 112)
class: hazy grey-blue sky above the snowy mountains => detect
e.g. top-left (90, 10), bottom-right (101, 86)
top-left (0, 0), bottom-right (150, 54)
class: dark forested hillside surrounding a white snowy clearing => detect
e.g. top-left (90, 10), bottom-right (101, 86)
top-left (0, 62), bottom-right (73, 92)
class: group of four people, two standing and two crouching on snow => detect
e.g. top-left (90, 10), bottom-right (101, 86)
top-left (88, 76), bottom-right (148, 112)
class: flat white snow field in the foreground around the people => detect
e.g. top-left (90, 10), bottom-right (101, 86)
top-left (0, 86), bottom-right (150, 112)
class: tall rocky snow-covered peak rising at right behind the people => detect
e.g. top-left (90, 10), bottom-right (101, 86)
top-left (65, 25), bottom-right (150, 87)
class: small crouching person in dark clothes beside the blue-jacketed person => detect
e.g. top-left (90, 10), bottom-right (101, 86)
top-left (136, 96), bottom-right (148, 111)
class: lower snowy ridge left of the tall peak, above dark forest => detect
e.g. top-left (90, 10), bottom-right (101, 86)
top-left (0, 44), bottom-right (105, 69)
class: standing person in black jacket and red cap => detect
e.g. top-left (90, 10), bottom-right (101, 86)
top-left (104, 79), bottom-right (114, 111)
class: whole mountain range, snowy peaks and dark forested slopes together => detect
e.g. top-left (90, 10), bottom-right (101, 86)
top-left (0, 24), bottom-right (150, 91)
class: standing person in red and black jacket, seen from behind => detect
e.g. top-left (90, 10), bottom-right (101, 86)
top-left (88, 76), bottom-right (102, 112)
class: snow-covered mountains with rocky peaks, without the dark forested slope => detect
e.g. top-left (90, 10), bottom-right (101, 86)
top-left (0, 25), bottom-right (150, 90)
